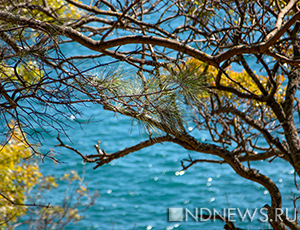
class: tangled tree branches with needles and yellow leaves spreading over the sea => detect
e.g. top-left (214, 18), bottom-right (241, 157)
top-left (0, 0), bottom-right (300, 230)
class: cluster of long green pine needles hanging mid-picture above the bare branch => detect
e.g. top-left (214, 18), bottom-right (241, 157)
top-left (89, 64), bottom-right (195, 132)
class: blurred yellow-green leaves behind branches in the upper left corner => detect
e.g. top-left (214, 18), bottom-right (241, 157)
top-left (0, 0), bottom-right (82, 86)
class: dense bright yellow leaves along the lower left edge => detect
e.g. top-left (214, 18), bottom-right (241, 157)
top-left (0, 126), bottom-right (42, 225)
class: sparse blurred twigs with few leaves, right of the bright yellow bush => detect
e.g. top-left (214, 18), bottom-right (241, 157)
top-left (25, 170), bottom-right (98, 230)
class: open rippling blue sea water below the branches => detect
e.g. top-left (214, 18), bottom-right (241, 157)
top-left (24, 105), bottom-right (296, 230)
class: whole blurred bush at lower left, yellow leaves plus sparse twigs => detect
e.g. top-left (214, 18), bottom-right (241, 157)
top-left (0, 125), bottom-right (98, 229)
